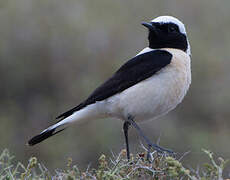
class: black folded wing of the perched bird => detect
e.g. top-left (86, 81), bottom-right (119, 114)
top-left (57, 50), bottom-right (172, 120)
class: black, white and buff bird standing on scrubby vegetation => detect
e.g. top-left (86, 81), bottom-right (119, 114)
top-left (28, 16), bottom-right (191, 160)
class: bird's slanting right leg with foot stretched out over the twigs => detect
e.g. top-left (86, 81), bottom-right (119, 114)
top-left (128, 116), bottom-right (174, 160)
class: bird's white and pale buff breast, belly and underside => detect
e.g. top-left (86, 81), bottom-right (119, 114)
top-left (44, 48), bottom-right (191, 131)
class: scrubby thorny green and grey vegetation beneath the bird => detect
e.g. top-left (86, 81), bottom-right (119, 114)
top-left (0, 149), bottom-right (227, 180)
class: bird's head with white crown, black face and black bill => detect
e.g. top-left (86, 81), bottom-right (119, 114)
top-left (142, 16), bottom-right (191, 55)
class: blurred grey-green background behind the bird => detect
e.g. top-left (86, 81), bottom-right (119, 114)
top-left (0, 0), bottom-right (230, 173)
